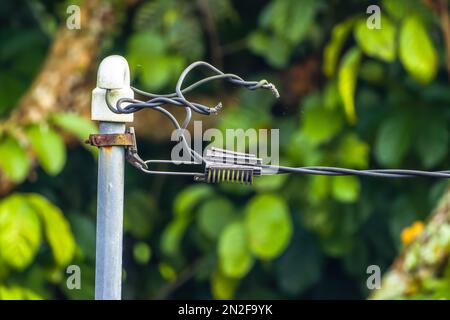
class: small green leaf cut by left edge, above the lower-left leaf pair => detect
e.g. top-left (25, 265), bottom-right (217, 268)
top-left (0, 136), bottom-right (30, 183)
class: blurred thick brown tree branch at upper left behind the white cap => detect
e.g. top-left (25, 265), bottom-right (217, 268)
top-left (0, 0), bottom-right (115, 195)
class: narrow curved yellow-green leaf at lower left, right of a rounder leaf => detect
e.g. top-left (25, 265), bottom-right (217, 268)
top-left (27, 194), bottom-right (76, 266)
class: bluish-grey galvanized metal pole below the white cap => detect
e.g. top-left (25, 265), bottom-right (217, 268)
top-left (95, 122), bottom-right (125, 300)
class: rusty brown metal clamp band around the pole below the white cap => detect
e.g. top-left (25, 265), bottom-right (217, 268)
top-left (85, 127), bottom-right (148, 170)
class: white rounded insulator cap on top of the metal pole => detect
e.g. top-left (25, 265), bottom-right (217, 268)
top-left (91, 55), bottom-right (134, 122)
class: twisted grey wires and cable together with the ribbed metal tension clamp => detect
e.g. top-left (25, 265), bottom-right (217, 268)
top-left (105, 61), bottom-right (450, 184)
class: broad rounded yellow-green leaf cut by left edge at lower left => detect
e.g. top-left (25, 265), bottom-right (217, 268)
top-left (0, 194), bottom-right (41, 270)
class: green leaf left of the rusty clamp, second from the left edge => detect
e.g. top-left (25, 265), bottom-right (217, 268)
top-left (26, 125), bottom-right (66, 175)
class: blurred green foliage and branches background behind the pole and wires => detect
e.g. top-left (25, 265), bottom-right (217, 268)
top-left (0, 0), bottom-right (450, 299)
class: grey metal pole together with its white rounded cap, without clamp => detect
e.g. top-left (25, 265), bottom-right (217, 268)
top-left (91, 56), bottom-right (133, 300)
